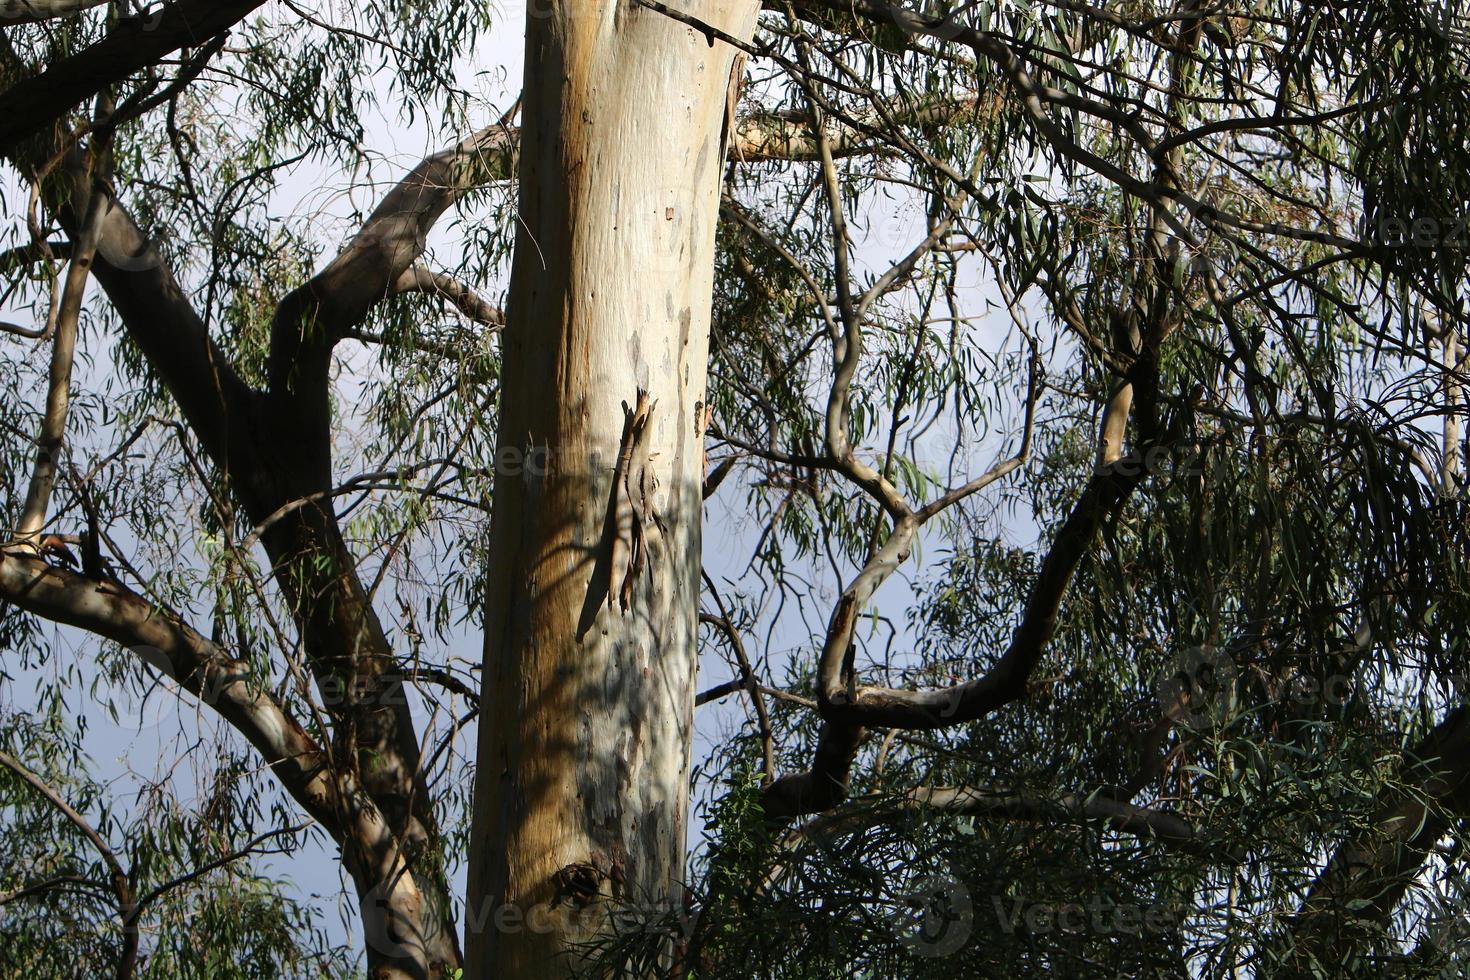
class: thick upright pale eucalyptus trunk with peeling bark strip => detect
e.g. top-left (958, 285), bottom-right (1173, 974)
top-left (466, 0), bottom-right (757, 977)
